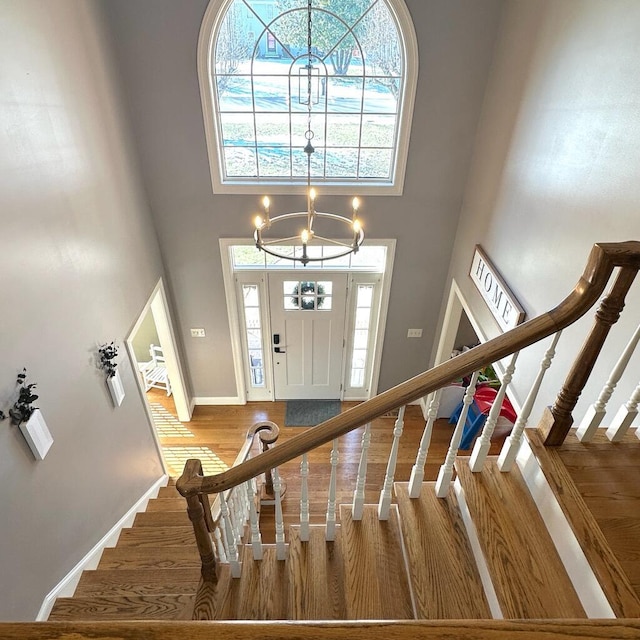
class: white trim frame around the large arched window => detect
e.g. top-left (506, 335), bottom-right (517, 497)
top-left (198, 0), bottom-right (418, 196)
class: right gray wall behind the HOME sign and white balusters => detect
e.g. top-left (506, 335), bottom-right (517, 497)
top-left (440, 0), bottom-right (640, 423)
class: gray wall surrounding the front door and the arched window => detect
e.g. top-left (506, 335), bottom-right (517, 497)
top-left (104, 0), bottom-right (502, 397)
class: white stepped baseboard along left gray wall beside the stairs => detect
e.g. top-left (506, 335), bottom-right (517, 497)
top-left (36, 475), bottom-right (169, 622)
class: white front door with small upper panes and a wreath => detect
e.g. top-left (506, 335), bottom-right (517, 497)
top-left (269, 271), bottom-right (347, 400)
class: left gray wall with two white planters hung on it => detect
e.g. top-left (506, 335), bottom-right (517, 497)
top-left (0, 0), bottom-right (168, 620)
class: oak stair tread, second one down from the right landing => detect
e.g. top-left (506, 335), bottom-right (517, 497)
top-left (395, 482), bottom-right (492, 620)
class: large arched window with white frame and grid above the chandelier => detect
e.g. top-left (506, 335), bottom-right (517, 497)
top-left (198, 0), bottom-right (418, 195)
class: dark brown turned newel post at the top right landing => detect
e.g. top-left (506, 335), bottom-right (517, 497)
top-left (538, 267), bottom-right (638, 446)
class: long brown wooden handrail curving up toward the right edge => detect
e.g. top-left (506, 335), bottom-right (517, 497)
top-left (176, 241), bottom-right (640, 497)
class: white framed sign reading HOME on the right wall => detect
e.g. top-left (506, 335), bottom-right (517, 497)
top-left (469, 245), bottom-right (525, 331)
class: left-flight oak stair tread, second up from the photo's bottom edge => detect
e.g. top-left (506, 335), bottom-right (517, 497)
top-left (74, 567), bottom-right (200, 597)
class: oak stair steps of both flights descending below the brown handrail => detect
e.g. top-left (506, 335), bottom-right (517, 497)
top-left (49, 450), bottom-right (604, 621)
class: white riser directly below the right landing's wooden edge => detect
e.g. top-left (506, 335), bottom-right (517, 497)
top-left (516, 439), bottom-right (616, 618)
